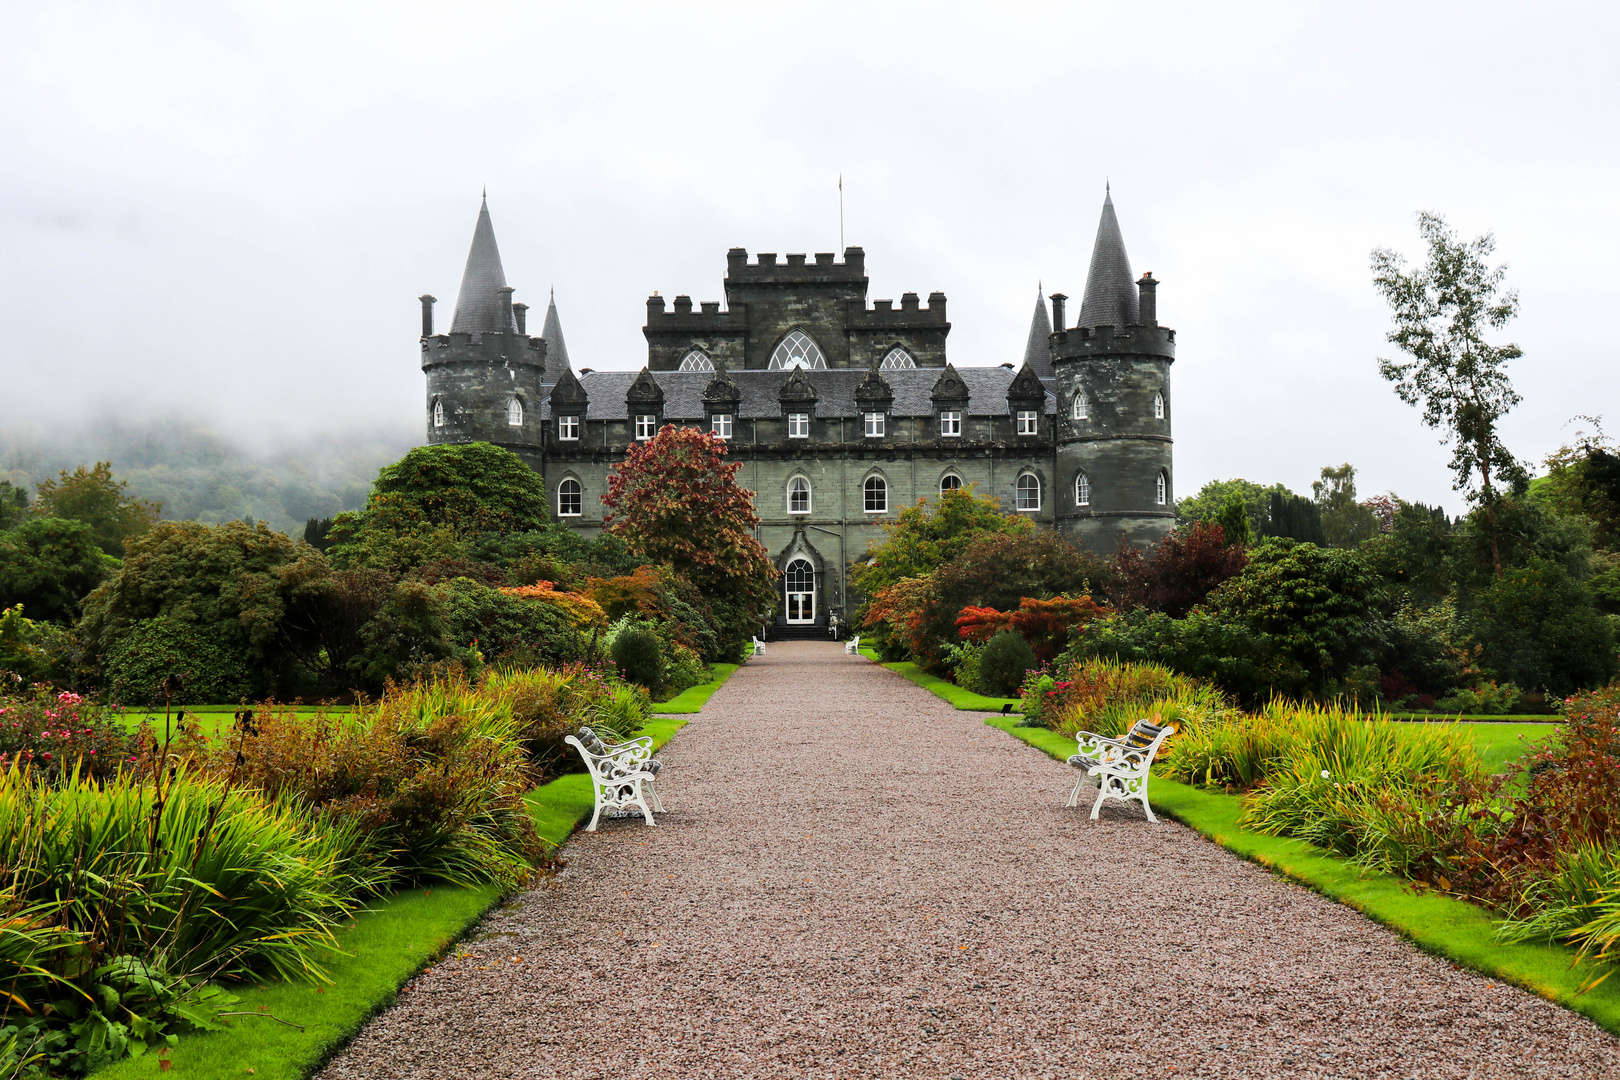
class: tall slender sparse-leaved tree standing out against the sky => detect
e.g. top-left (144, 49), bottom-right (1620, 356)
top-left (1372, 212), bottom-right (1524, 576)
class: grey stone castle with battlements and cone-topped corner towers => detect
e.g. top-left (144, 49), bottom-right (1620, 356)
top-left (421, 194), bottom-right (1176, 627)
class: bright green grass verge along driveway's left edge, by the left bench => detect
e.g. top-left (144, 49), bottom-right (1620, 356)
top-left (96, 719), bottom-right (685, 1080)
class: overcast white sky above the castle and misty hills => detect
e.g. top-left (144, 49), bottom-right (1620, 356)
top-left (0, 0), bottom-right (1620, 512)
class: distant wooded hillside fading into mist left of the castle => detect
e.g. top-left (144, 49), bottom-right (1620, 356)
top-left (0, 419), bottom-right (413, 536)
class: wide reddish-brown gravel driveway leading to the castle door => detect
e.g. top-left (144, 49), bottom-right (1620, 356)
top-left (321, 643), bottom-right (1620, 1080)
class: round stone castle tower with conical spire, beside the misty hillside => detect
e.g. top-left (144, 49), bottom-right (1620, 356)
top-left (421, 201), bottom-right (546, 471)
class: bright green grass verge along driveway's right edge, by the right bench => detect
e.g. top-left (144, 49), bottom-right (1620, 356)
top-left (985, 716), bottom-right (1620, 1035)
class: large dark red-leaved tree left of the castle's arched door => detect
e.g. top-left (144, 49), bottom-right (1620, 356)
top-left (603, 424), bottom-right (776, 646)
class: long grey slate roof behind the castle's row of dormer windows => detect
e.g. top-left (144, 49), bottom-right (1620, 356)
top-left (544, 368), bottom-right (1056, 419)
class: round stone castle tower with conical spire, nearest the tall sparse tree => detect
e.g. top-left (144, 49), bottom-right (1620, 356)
top-left (1051, 194), bottom-right (1176, 554)
